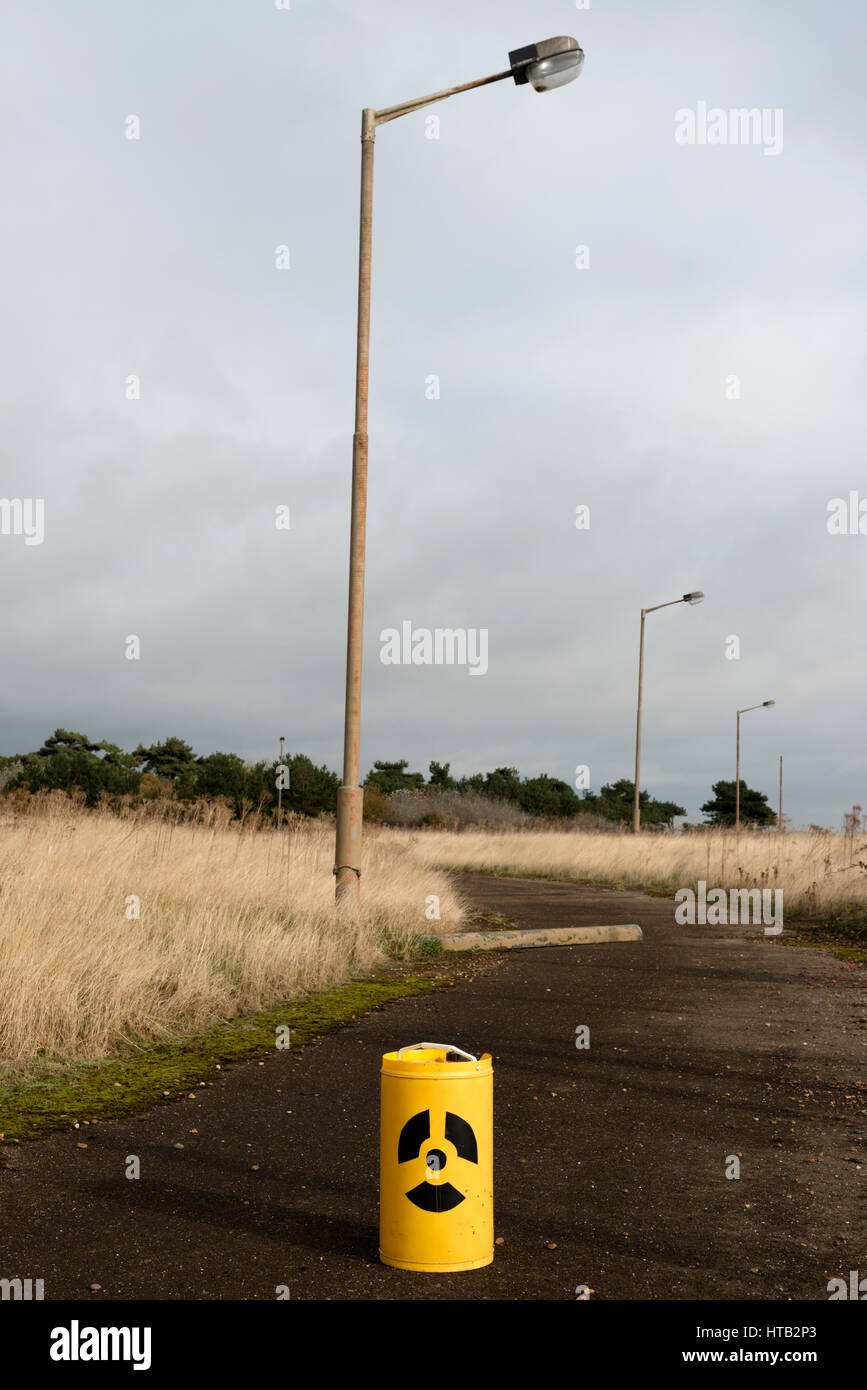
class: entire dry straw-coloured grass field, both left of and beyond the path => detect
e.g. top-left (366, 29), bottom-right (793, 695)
top-left (0, 792), bottom-right (867, 1068)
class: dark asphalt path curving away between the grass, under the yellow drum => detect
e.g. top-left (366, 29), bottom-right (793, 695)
top-left (0, 876), bottom-right (867, 1302)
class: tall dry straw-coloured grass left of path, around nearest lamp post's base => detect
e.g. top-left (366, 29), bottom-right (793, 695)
top-left (0, 794), bottom-right (463, 1065)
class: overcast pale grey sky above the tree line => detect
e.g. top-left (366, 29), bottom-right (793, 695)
top-left (0, 0), bottom-right (867, 824)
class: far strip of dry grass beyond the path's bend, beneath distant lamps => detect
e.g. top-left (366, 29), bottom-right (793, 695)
top-left (392, 830), bottom-right (867, 912)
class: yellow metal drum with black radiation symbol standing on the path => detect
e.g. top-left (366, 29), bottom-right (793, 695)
top-left (379, 1043), bottom-right (493, 1273)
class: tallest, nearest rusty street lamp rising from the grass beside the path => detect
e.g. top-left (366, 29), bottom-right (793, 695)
top-left (333, 36), bottom-right (584, 902)
